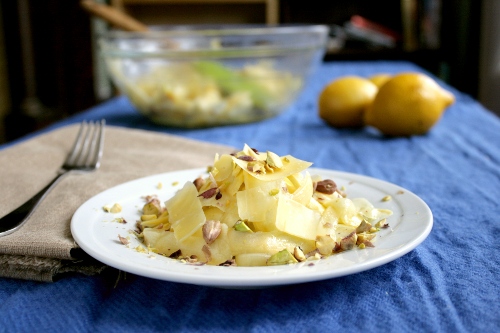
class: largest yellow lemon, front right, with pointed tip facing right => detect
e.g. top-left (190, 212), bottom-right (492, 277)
top-left (365, 72), bottom-right (455, 136)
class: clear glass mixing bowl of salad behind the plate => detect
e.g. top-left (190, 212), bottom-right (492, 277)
top-left (99, 25), bottom-right (328, 128)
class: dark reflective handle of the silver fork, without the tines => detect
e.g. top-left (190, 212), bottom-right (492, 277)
top-left (0, 171), bottom-right (67, 237)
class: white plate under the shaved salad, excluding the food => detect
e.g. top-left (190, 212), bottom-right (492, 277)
top-left (71, 168), bottom-right (433, 288)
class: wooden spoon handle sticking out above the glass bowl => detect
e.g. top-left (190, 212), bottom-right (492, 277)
top-left (80, 0), bottom-right (148, 31)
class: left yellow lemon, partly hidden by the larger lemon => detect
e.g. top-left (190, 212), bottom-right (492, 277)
top-left (318, 76), bottom-right (378, 127)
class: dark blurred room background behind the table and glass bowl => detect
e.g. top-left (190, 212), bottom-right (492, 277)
top-left (0, 0), bottom-right (500, 143)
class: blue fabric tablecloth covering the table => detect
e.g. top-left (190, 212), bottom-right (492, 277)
top-left (0, 61), bottom-right (500, 332)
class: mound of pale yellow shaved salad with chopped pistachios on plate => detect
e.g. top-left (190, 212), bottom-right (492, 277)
top-left (138, 145), bottom-right (392, 266)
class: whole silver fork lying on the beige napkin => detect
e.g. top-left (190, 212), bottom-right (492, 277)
top-left (0, 119), bottom-right (106, 237)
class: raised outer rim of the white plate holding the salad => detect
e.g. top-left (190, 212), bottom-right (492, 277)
top-left (70, 167), bottom-right (434, 288)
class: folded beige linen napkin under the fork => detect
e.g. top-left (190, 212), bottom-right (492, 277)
top-left (0, 125), bottom-right (235, 281)
